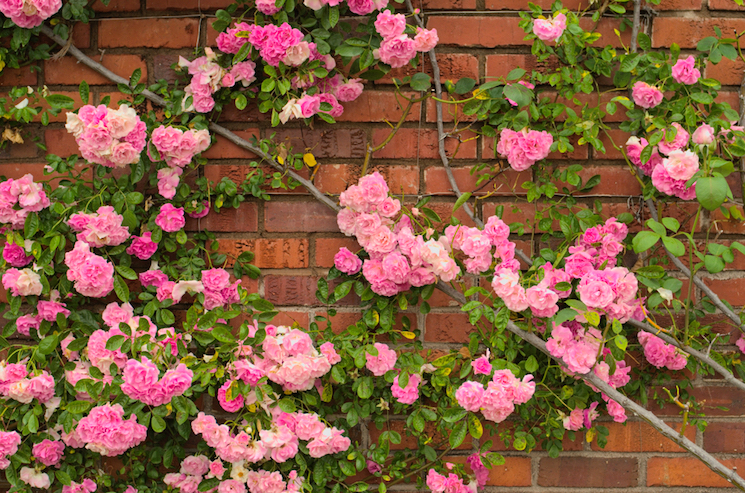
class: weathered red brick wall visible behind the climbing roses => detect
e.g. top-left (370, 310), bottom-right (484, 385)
top-left (0, 0), bottom-right (745, 493)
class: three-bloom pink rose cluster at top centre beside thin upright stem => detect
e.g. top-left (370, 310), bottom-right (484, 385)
top-left (375, 10), bottom-right (439, 68)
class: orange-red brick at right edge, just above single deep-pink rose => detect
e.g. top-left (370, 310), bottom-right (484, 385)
top-left (652, 17), bottom-right (745, 48)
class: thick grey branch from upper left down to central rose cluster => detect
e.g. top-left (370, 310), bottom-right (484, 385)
top-left (41, 26), bottom-right (340, 211)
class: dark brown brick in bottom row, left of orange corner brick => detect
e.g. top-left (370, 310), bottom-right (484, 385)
top-left (538, 456), bottom-right (639, 488)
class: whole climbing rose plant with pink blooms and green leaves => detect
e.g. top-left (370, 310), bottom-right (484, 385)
top-left (0, 0), bottom-right (745, 493)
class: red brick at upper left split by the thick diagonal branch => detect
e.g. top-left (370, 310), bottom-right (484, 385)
top-left (44, 54), bottom-right (147, 86)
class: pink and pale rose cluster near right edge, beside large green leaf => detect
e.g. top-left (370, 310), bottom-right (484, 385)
top-left (626, 122), bottom-right (700, 200)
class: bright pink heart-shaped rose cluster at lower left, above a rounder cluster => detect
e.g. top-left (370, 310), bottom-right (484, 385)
top-left (122, 357), bottom-right (194, 407)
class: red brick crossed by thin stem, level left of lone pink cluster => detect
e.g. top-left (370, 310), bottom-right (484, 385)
top-left (372, 128), bottom-right (477, 159)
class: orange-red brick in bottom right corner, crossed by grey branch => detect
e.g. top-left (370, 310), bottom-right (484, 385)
top-left (647, 457), bottom-right (745, 488)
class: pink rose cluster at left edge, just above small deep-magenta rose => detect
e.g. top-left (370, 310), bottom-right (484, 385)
top-left (0, 174), bottom-right (50, 229)
